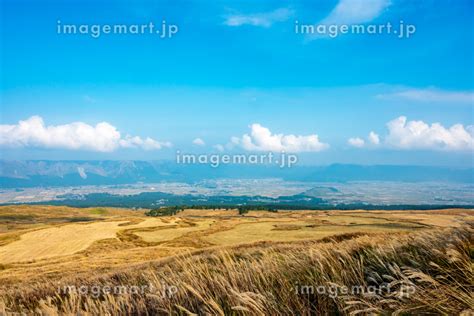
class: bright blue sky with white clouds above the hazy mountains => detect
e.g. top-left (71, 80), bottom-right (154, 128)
top-left (0, 0), bottom-right (474, 166)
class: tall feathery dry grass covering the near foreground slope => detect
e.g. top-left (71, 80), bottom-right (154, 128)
top-left (0, 225), bottom-right (474, 315)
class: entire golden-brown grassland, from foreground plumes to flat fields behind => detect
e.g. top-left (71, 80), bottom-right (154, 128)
top-left (0, 206), bottom-right (474, 315)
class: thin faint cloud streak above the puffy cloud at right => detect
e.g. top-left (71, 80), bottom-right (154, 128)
top-left (377, 88), bottom-right (474, 104)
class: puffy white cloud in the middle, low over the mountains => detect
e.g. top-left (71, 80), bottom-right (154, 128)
top-left (231, 123), bottom-right (329, 152)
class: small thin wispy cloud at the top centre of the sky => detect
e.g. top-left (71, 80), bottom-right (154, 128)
top-left (224, 8), bottom-right (294, 27)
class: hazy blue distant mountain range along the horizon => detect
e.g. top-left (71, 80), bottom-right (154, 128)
top-left (0, 160), bottom-right (474, 188)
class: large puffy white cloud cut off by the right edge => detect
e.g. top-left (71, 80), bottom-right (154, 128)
top-left (385, 116), bottom-right (474, 150)
